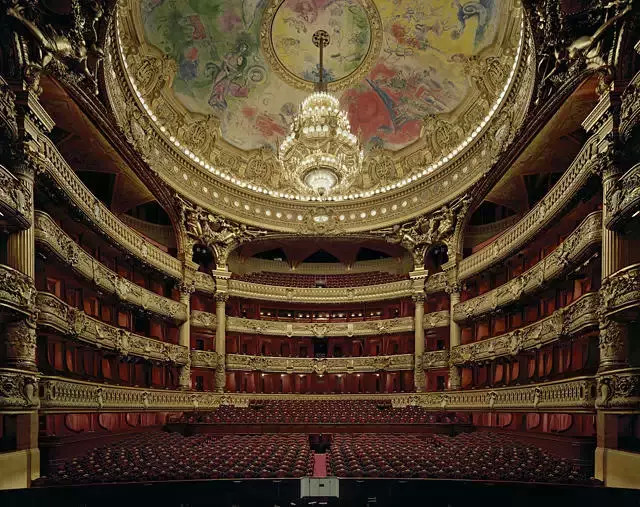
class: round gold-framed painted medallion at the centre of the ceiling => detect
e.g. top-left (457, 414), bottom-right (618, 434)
top-left (260, 0), bottom-right (383, 91)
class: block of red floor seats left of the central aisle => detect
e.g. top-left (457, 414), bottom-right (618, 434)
top-left (34, 431), bottom-right (313, 486)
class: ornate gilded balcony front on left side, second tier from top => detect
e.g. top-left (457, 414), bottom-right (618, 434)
top-left (35, 211), bottom-right (187, 322)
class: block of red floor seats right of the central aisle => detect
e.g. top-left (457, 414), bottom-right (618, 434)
top-left (327, 433), bottom-right (589, 483)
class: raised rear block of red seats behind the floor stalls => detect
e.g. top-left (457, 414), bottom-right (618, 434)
top-left (179, 400), bottom-right (469, 424)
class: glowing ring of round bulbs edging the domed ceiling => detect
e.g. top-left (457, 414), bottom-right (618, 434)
top-left (116, 15), bottom-right (524, 202)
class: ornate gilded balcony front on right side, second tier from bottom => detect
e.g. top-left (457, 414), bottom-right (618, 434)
top-left (451, 292), bottom-right (601, 366)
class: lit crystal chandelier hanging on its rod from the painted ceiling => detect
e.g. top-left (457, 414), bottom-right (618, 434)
top-left (278, 30), bottom-right (363, 196)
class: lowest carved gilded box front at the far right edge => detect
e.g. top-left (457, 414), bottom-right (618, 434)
top-left (596, 368), bottom-right (640, 411)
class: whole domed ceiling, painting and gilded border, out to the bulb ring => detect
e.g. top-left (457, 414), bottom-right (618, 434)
top-left (119, 0), bottom-right (521, 200)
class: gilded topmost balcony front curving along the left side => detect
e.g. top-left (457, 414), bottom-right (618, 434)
top-left (38, 136), bottom-right (182, 280)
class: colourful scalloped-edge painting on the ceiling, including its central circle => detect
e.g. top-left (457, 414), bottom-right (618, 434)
top-left (140, 0), bottom-right (501, 150)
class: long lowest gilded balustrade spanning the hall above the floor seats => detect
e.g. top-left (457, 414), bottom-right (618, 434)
top-left (40, 376), bottom-right (596, 414)
